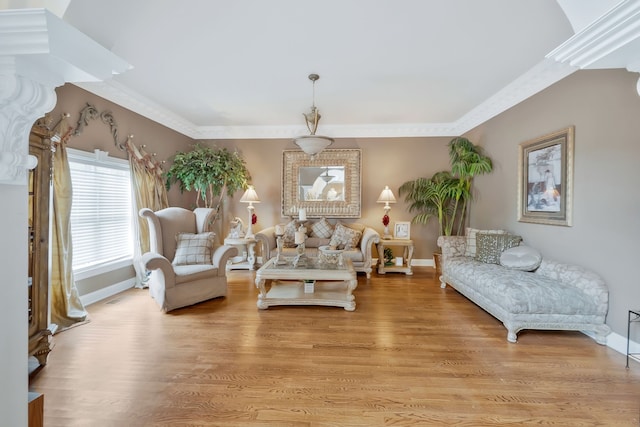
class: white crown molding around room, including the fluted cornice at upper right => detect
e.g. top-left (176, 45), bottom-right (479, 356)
top-left (71, 0), bottom-right (640, 139)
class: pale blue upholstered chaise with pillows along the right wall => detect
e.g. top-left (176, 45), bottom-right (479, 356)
top-left (438, 229), bottom-right (610, 345)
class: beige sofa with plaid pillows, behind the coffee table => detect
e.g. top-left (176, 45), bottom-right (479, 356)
top-left (255, 218), bottom-right (380, 279)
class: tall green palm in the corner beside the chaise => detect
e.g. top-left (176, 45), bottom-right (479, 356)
top-left (398, 137), bottom-right (493, 274)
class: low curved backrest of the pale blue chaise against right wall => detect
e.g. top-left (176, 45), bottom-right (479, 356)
top-left (534, 258), bottom-right (609, 316)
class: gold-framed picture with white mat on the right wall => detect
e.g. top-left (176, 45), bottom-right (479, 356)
top-left (518, 126), bottom-right (574, 227)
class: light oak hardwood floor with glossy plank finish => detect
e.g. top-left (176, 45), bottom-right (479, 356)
top-left (30, 267), bottom-right (640, 427)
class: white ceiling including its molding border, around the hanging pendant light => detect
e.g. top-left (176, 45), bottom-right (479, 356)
top-left (5, 0), bottom-right (636, 139)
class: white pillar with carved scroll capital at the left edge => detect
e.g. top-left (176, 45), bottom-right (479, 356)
top-left (0, 9), bottom-right (130, 426)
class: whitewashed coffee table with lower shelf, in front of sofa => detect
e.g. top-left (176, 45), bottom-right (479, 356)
top-left (256, 258), bottom-right (358, 311)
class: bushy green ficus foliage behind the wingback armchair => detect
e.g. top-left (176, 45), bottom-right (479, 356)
top-left (165, 144), bottom-right (251, 227)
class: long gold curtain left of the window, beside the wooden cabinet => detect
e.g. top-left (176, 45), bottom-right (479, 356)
top-left (51, 118), bottom-right (87, 331)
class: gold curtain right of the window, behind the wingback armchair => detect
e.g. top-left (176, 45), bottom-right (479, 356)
top-left (126, 138), bottom-right (169, 288)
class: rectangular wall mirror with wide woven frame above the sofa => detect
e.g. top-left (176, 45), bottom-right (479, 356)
top-left (282, 150), bottom-right (360, 218)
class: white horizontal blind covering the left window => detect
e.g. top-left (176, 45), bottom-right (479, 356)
top-left (67, 149), bottom-right (134, 272)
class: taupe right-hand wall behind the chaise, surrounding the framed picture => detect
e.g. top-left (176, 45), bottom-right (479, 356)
top-left (468, 70), bottom-right (640, 340)
